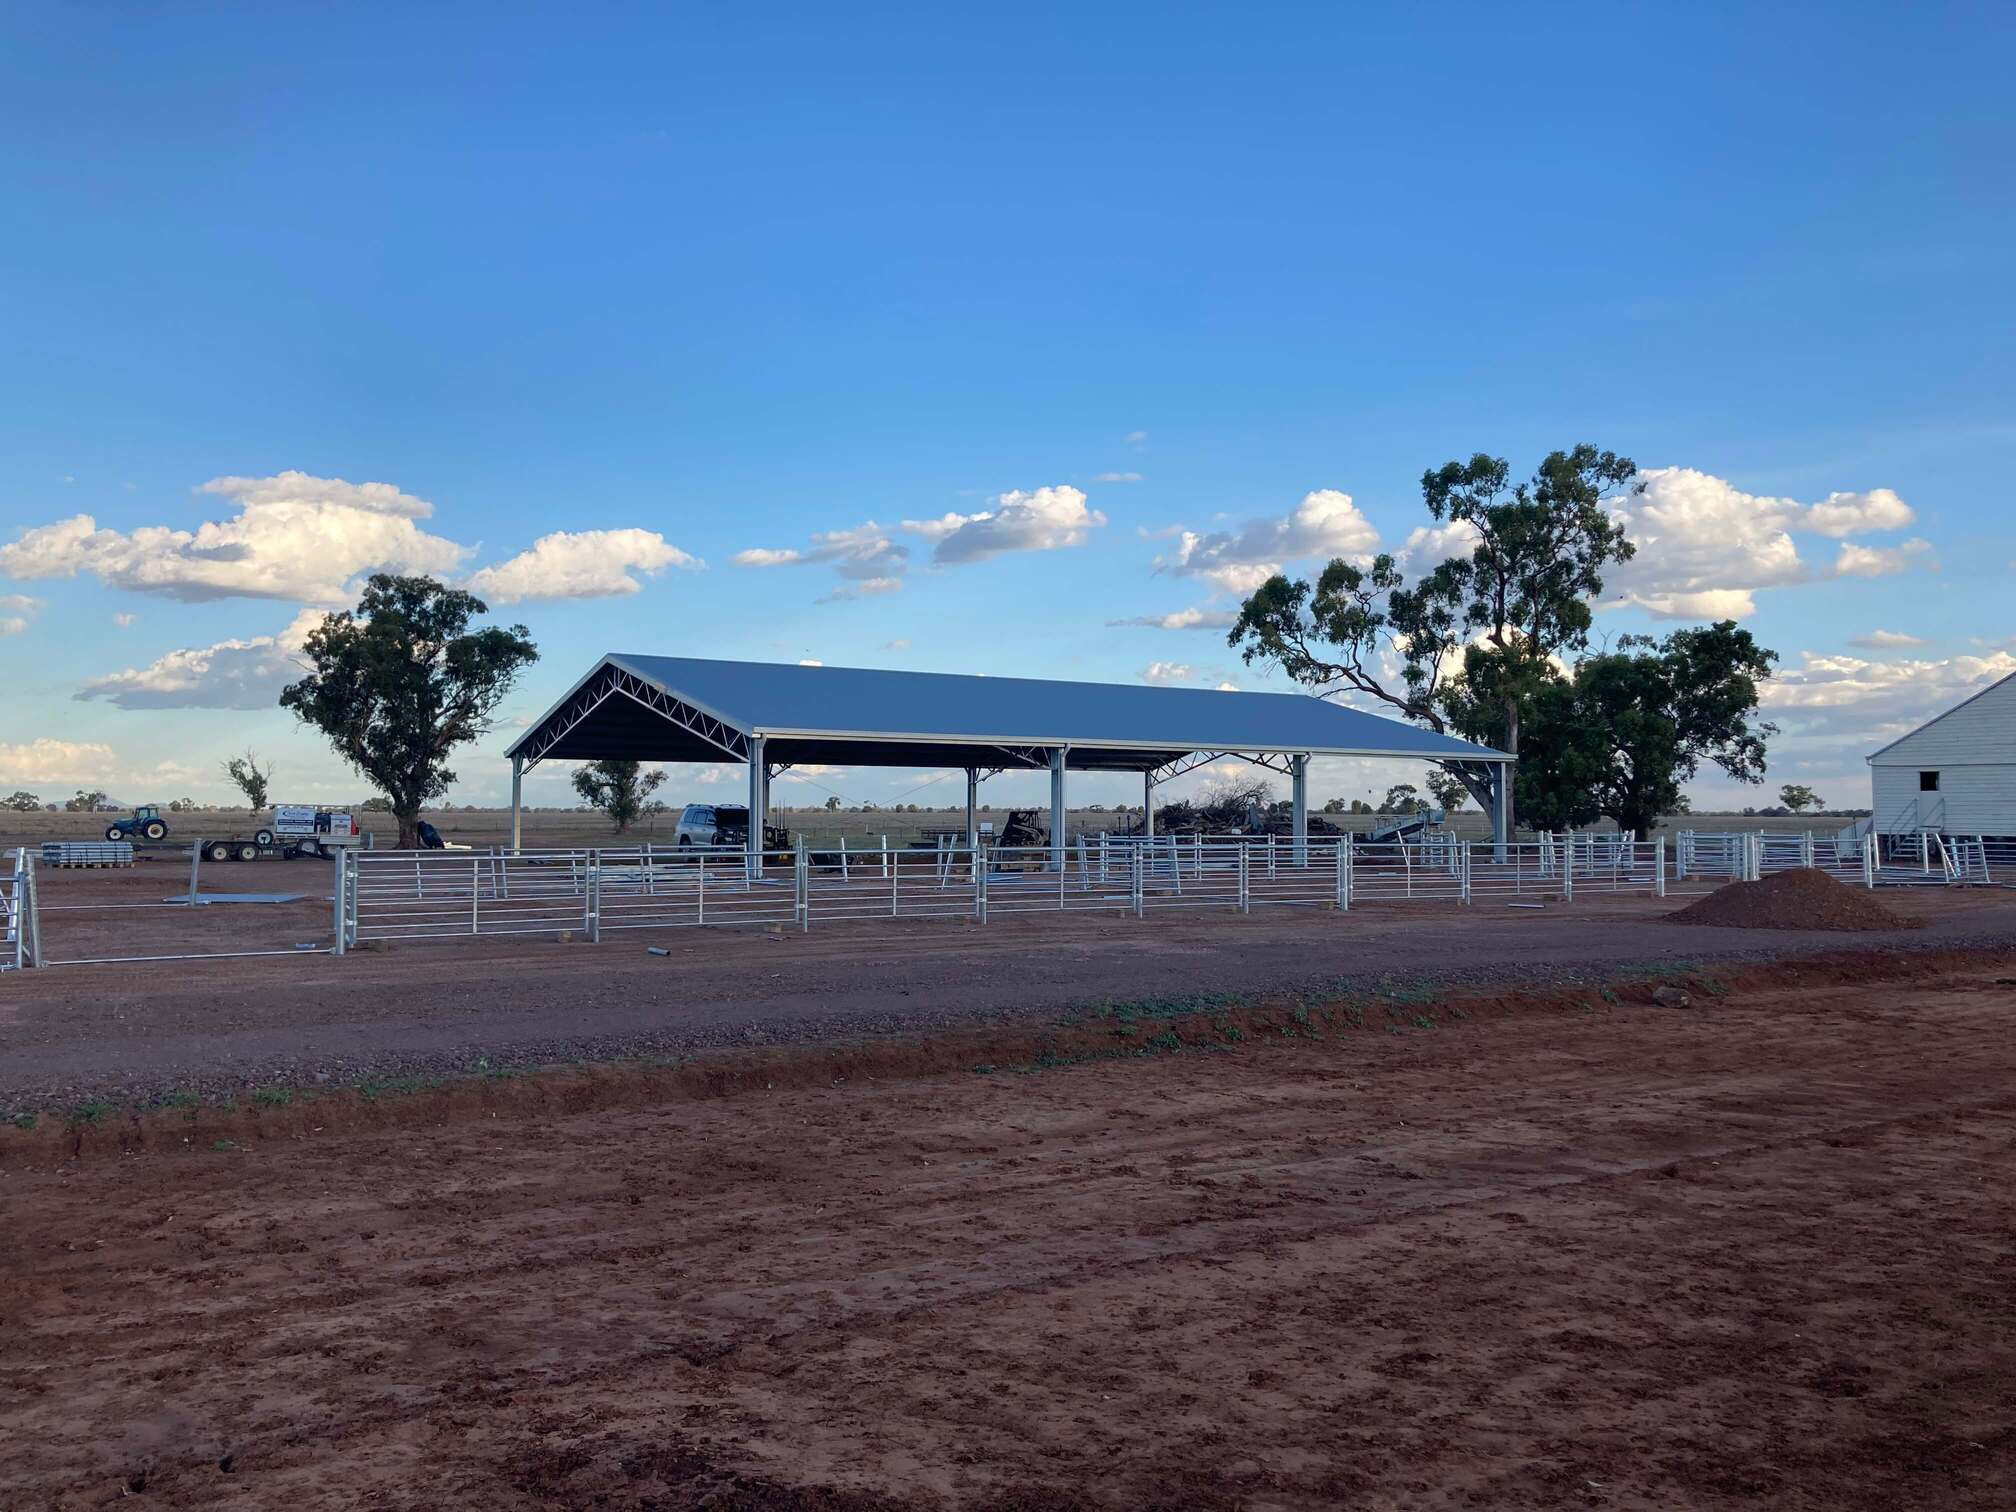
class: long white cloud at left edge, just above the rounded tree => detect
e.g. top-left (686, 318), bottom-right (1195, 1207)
top-left (0, 472), bottom-right (468, 605)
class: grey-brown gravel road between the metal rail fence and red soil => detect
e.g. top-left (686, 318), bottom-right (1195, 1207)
top-left (0, 861), bottom-right (2016, 1115)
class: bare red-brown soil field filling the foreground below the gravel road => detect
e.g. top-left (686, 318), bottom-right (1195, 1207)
top-left (0, 951), bottom-right (2016, 1512)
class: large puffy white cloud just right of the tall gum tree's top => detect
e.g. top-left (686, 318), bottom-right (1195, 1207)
top-left (1605, 468), bottom-right (1925, 619)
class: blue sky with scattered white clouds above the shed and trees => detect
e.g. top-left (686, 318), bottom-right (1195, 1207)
top-left (0, 6), bottom-right (2016, 818)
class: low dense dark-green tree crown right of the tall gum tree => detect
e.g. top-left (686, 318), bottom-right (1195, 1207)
top-left (1507, 619), bottom-right (1778, 839)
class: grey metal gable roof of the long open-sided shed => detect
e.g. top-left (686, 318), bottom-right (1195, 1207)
top-left (510, 653), bottom-right (1512, 772)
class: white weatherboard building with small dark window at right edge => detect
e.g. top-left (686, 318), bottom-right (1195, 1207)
top-left (1869, 675), bottom-right (2016, 837)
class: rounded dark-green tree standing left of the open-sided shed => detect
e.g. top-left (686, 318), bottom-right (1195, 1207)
top-left (280, 573), bottom-right (538, 849)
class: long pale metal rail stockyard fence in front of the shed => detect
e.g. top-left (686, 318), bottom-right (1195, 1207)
top-left (0, 831), bottom-right (2016, 970)
